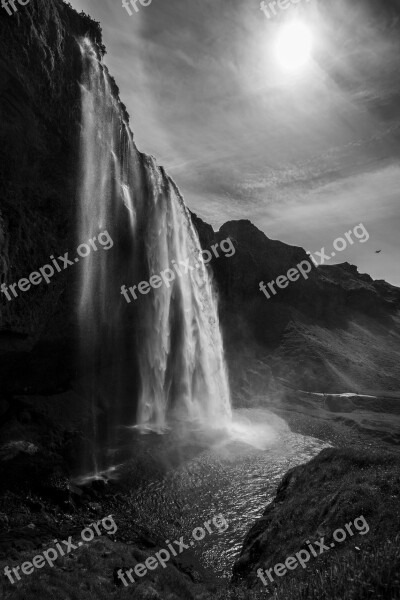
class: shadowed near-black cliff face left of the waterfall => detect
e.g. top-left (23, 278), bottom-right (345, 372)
top-left (0, 0), bottom-right (109, 392)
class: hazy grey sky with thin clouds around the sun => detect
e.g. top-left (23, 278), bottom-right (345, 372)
top-left (70, 0), bottom-right (400, 286)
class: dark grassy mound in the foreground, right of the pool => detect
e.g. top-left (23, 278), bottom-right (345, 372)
top-left (222, 449), bottom-right (400, 600)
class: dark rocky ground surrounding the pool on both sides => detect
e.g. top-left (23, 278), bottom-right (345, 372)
top-left (0, 378), bottom-right (400, 600)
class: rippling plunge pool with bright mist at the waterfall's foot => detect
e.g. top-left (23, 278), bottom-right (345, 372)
top-left (73, 408), bottom-right (328, 577)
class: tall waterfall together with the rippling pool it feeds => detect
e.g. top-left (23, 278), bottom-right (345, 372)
top-left (78, 41), bottom-right (330, 575)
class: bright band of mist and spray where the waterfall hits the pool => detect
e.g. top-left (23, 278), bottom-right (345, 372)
top-left (74, 408), bottom-right (321, 485)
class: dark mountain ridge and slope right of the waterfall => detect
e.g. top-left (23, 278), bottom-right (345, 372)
top-left (193, 215), bottom-right (400, 401)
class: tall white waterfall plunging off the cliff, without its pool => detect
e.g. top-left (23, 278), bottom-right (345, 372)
top-left (79, 40), bottom-right (231, 471)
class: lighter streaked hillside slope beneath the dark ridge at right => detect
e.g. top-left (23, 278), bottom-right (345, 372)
top-left (269, 314), bottom-right (400, 394)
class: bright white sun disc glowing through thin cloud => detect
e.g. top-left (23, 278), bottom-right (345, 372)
top-left (275, 21), bottom-right (312, 70)
